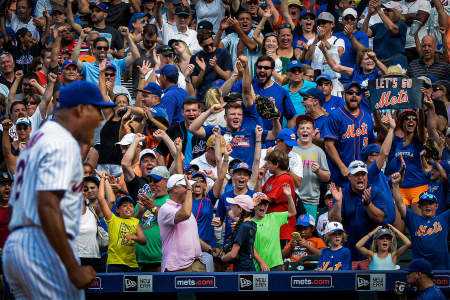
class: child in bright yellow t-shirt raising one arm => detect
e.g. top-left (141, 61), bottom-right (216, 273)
top-left (98, 172), bottom-right (146, 272)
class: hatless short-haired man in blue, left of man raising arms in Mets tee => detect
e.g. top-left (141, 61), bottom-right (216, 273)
top-left (155, 98), bottom-right (206, 165)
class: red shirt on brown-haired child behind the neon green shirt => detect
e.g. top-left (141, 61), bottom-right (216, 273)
top-left (262, 173), bottom-right (297, 240)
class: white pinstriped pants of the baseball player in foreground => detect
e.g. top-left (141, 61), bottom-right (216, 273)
top-left (2, 227), bottom-right (84, 300)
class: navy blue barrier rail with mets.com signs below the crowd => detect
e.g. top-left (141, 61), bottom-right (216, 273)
top-left (88, 270), bottom-right (450, 294)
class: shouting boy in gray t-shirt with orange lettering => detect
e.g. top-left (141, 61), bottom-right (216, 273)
top-left (292, 115), bottom-right (330, 220)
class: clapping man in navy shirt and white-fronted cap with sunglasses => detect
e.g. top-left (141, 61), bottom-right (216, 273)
top-left (328, 160), bottom-right (387, 270)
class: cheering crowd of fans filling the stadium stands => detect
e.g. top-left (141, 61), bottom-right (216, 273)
top-left (0, 0), bottom-right (450, 295)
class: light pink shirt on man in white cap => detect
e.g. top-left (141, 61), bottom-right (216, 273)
top-left (158, 199), bottom-right (202, 272)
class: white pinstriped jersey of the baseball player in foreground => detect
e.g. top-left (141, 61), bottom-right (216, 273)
top-left (9, 121), bottom-right (83, 237)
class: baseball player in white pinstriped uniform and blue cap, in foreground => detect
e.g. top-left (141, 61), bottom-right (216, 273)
top-left (2, 81), bottom-right (115, 300)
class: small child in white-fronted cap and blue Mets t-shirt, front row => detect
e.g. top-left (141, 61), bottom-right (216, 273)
top-left (316, 222), bottom-right (352, 271)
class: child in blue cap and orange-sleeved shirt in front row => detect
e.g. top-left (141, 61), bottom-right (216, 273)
top-left (282, 214), bottom-right (327, 262)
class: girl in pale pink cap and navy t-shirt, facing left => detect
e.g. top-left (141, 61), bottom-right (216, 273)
top-left (221, 195), bottom-right (268, 272)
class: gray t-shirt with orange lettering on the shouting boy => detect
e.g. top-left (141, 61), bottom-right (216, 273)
top-left (292, 144), bottom-right (330, 205)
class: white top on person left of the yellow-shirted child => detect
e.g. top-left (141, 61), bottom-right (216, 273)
top-left (73, 207), bottom-right (100, 258)
